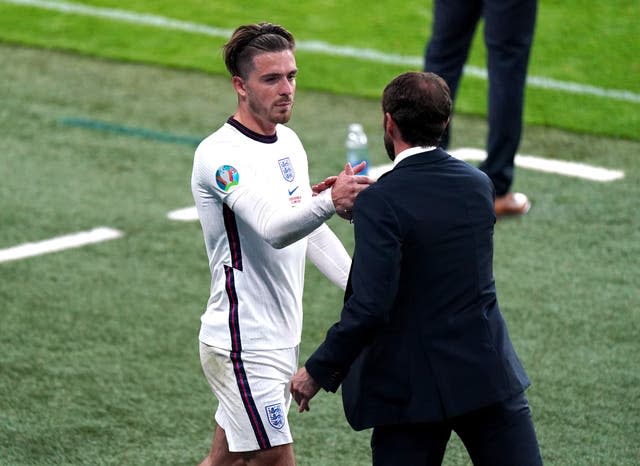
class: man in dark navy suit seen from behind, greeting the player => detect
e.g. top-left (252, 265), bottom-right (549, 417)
top-left (291, 72), bottom-right (542, 466)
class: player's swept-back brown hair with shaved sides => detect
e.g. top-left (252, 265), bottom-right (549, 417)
top-left (223, 23), bottom-right (296, 79)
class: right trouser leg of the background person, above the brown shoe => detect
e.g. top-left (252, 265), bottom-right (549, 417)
top-left (480, 0), bottom-right (537, 196)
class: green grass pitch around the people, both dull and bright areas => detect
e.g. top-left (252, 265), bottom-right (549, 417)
top-left (0, 0), bottom-right (640, 466)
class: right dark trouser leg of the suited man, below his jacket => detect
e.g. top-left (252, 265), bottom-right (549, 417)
top-left (452, 393), bottom-right (542, 466)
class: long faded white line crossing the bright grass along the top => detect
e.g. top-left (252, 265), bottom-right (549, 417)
top-left (0, 0), bottom-right (640, 103)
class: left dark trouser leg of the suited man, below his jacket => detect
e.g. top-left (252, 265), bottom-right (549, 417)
top-left (371, 423), bottom-right (451, 466)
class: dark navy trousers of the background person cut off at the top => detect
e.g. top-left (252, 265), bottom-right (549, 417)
top-left (424, 0), bottom-right (537, 195)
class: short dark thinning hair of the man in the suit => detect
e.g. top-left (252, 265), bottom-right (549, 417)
top-left (382, 71), bottom-right (451, 146)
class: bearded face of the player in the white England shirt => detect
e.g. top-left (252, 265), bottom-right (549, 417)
top-left (241, 50), bottom-right (298, 128)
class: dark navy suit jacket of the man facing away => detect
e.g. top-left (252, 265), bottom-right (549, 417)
top-left (305, 149), bottom-right (529, 430)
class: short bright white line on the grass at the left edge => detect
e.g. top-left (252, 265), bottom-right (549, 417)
top-left (0, 227), bottom-right (123, 263)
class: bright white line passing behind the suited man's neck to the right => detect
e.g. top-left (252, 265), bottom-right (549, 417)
top-left (369, 147), bottom-right (624, 182)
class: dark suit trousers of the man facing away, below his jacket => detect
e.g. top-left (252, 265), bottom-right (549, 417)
top-left (371, 393), bottom-right (542, 466)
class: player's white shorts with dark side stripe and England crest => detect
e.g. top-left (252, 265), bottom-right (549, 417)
top-left (200, 342), bottom-right (298, 452)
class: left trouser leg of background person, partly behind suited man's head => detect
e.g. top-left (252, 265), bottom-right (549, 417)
top-left (424, 0), bottom-right (482, 149)
